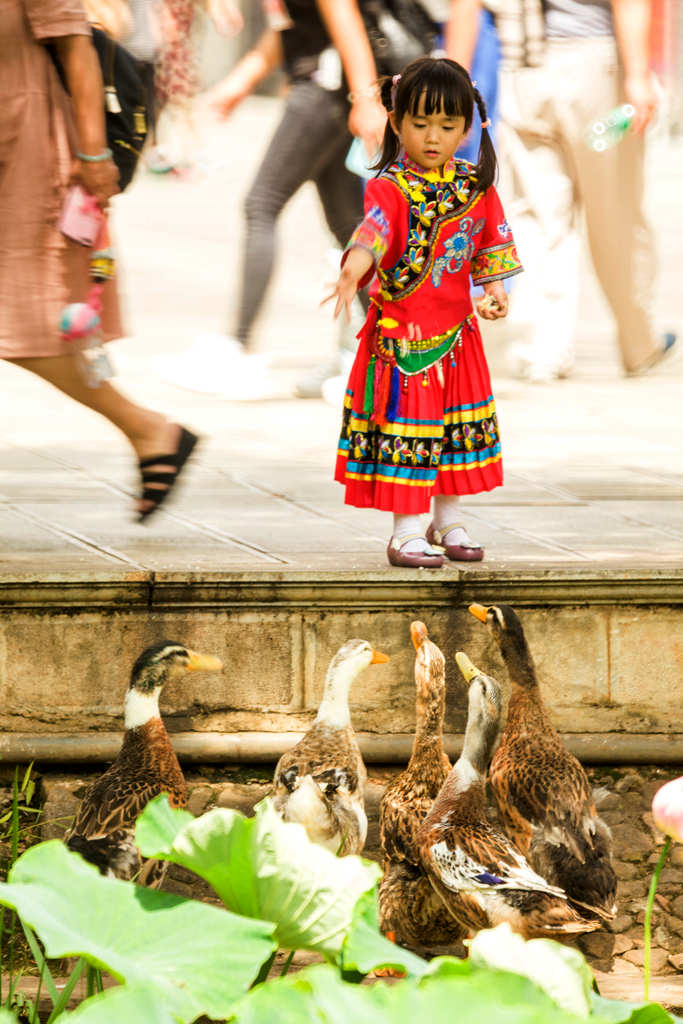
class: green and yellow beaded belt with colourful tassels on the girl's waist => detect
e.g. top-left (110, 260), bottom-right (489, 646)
top-left (362, 313), bottom-right (474, 424)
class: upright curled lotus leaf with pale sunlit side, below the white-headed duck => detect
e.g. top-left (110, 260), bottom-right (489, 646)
top-left (135, 797), bottom-right (381, 957)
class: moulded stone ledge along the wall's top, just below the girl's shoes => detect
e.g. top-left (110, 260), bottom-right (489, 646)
top-left (0, 566), bottom-right (683, 610)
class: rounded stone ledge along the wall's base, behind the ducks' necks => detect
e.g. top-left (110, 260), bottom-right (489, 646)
top-left (0, 732), bottom-right (683, 765)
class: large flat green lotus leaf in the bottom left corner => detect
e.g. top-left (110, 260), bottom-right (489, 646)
top-left (0, 840), bottom-right (275, 1021)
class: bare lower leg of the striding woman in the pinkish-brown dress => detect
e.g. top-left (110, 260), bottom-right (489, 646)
top-left (8, 355), bottom-right (180, 512)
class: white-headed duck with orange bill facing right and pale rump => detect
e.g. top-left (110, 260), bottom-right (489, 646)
top-left (271, 639), bottom-right (389, 856)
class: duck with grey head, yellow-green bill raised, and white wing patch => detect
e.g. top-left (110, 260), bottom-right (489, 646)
top-left (418, 651), bottom-right (599, 939)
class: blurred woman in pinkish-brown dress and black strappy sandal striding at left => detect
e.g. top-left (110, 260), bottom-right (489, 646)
top-left (0, 0), bottom-right (197, 519)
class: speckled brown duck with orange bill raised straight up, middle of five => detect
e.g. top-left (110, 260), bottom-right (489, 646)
top-left (378, 621), bottom-right (463, 951)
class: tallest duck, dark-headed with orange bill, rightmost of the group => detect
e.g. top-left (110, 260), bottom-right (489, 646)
top-left (469, 604), bottom-right (616, 921)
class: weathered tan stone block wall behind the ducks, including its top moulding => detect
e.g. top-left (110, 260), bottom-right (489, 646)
top-left (0, 575), bottom-right (683, 761)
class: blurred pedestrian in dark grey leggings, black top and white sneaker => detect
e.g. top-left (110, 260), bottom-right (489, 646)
top-left (156, 0), bottom-right (386, 399)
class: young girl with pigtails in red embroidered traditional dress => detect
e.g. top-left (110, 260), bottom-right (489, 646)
top-left (330, 57), bottom-right (522, 568)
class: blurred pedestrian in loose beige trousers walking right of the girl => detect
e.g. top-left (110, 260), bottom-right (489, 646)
top-left (497, 0), bottom-right (680, 382)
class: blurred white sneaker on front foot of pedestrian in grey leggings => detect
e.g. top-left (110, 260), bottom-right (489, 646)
top-left (158, 333), bottom-right (272, 401)
